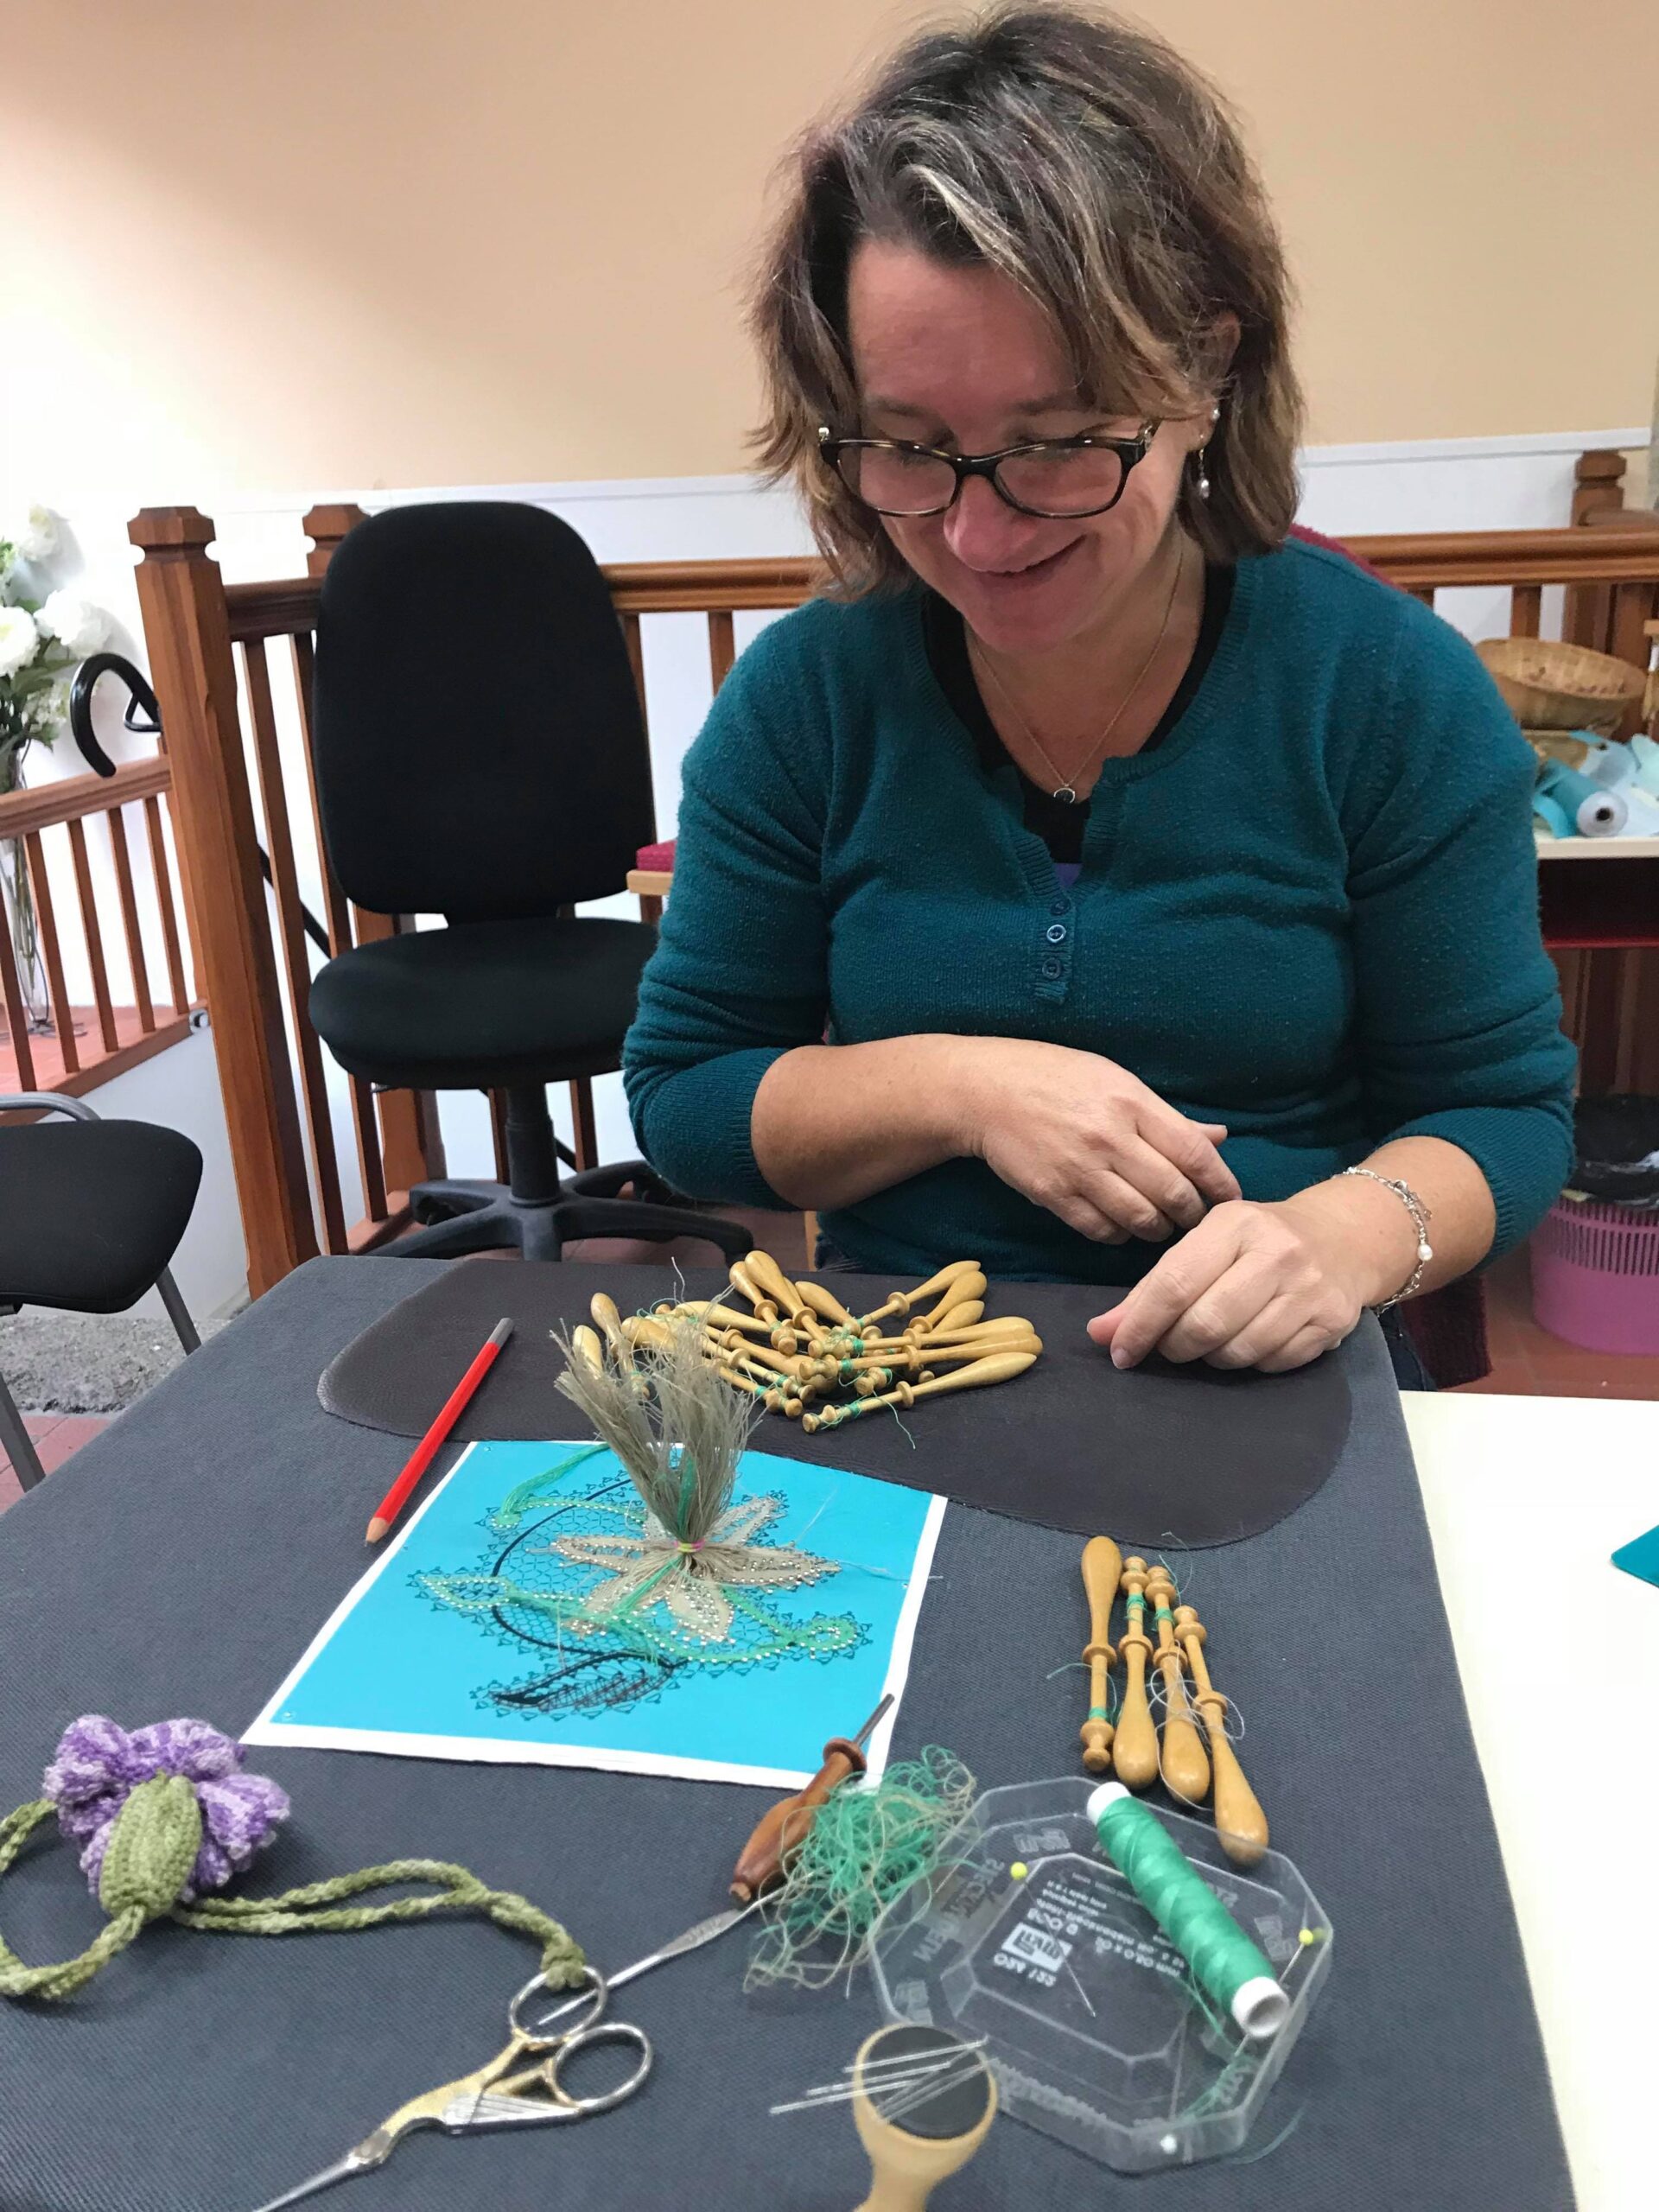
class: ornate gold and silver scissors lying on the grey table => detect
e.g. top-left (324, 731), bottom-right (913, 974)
top-left (259, 1907), bottom-right (750, 2212)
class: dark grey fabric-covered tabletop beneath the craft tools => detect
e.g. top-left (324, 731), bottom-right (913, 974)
top-left (0, 1259), bottom-right (1573, 2212)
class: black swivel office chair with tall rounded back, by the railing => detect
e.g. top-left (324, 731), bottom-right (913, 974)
top-left (312, 500), bottom-right (752, 1259)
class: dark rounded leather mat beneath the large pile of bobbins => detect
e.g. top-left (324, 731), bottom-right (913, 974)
top-left (319, 1263), bottom-right (1353, 1546)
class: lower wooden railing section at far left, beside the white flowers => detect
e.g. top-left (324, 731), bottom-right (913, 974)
top-left (0, 754), bottom-right (193, 1095)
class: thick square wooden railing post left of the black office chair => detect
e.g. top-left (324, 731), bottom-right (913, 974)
top-left (128, 506), bottom-right (316, 1296)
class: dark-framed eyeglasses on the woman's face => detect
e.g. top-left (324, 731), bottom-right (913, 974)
top-left (818, 423), bottom-right (1159, 520)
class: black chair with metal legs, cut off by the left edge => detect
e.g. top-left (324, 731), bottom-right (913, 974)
top-left (0, 1090), bottom-right (201, 1491)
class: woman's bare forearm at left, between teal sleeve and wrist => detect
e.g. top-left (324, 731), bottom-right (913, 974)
top-left (750, 1035), bottom-right (976, 1212)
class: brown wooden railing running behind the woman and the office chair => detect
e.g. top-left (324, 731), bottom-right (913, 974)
top-left (130, 506), bottom-right (1659, 1296)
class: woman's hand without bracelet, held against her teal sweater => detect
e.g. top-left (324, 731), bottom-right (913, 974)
top-left (963, 1038), bottom-right (1239, 1243)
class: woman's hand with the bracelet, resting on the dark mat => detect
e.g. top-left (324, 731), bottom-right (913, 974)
top-left (1089, 1185), bottom-right (1415, 1374)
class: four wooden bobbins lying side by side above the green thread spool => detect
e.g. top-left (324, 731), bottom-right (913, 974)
top-left (1079, 1535), bottom-right (1268, 1867)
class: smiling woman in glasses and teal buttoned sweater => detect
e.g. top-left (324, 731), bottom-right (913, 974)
top-left (626, 9), bottom-right (1573, 1374)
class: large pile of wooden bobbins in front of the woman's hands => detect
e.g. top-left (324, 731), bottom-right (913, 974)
top-left (593, 1252), bottom-right (1042, 1433)
